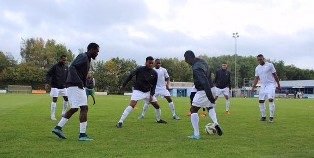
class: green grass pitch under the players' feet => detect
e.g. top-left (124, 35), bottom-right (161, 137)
top-left (0, 94), bottom-right (314, 158)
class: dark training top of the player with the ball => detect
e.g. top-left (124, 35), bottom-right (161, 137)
top-left (192, 58), bottom-right (215, 103)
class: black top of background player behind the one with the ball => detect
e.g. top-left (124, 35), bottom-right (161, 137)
top-left (214, 69), bottom-right (231, 89)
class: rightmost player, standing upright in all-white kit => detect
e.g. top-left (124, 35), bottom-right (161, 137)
top-left (251, 54), bottom-right (281, 123)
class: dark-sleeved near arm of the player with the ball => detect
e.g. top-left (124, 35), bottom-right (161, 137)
top-left (193, 68), bottom-right (215, 103)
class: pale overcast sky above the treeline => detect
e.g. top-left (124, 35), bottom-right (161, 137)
top-left (0, 0), bottom-right (314, 69)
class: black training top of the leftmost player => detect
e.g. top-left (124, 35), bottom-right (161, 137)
top-left (46, 62), bottom-right (68, 89)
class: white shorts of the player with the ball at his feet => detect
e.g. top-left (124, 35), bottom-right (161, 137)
top-left (192, 88), bottom-right (216, 108)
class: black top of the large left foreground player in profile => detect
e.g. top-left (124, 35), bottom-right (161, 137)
top-left (66, 52), bottom-right (91, 88)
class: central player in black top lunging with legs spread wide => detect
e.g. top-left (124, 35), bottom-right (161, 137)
top-left (117, 56), bottom-right (167, 128)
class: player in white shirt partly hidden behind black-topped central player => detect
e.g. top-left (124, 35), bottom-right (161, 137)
top-left (139, 59), bottom-right (180, 120)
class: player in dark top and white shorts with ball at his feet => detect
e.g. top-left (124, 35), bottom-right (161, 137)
top-left (184, 50), bottom-right (223, 140)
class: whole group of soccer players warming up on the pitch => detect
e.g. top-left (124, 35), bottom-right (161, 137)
top-left (45, 43), bottom-right (280, 141)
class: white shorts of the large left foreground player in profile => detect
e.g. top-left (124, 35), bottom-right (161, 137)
top-left (68, 87), bottom-right (87, 108)
